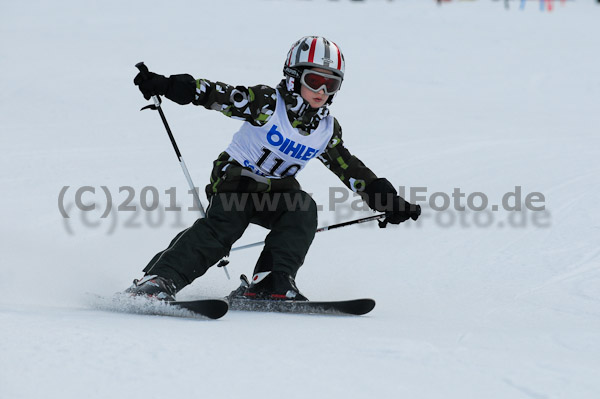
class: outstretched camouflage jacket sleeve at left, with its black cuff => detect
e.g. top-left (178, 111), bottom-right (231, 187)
top-left (165, 74), bottom-right (277, 126)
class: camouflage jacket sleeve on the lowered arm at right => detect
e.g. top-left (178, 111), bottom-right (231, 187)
top-left (319, 118), bottom-right (377, 201)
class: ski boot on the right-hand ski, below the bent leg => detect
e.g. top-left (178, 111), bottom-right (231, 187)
top-left (229, 271), bottom-right (308, 301)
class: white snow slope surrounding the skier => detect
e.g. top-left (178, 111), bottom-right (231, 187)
top-left (0, 0), bottom-right (600, 399)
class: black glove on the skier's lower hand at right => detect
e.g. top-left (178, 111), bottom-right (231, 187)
top-left (364, 179), bottom-right (421, 228)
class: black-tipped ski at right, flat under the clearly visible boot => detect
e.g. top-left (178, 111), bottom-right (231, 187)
top-left (227, 297), bottom-right (375, 316)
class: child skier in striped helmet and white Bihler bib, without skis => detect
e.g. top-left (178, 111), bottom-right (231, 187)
top-left (126, 36), bottom-right (421, 301)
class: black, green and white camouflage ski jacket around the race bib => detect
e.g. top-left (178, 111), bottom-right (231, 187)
top-left (166, 75), bottom-right (377, 200)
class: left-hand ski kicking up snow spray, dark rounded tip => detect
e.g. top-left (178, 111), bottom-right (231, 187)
top-left (91, 294), bottom-right (229, 319)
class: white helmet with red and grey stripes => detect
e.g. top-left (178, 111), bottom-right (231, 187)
top-left (283, 36), bottom-right (345, 79)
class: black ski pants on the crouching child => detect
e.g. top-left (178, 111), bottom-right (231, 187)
top-left (144, 190), bottom-right (317, 291)
